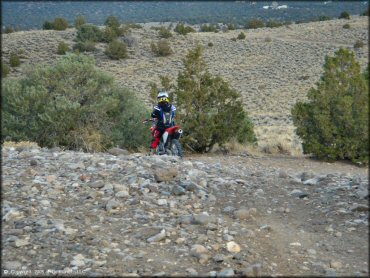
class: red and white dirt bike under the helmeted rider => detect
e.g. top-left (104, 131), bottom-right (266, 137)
top-left (143, 119), bottom-right (183, 158)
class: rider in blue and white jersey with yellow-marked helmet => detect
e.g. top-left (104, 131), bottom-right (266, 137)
top-left (150, 91), bottom-right (176, 152)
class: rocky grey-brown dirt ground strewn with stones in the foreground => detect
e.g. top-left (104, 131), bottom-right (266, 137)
top-left (2, 147), bottom-right (369, 277)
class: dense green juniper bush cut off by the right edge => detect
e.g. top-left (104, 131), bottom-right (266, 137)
top-left (292, 49), bottom-right (369, 163)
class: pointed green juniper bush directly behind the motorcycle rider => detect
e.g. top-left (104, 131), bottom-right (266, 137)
top-left (164, 46), bottom-right (256, 152)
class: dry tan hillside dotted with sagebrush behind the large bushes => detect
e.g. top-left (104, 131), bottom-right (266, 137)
top-left (2, 16), bottom-right (369, 153)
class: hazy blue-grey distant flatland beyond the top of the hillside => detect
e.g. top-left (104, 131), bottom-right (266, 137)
top-left (2, 1), bottom-right (369, 30)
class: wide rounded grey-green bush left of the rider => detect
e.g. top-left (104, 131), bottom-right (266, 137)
top-left (1, 53), bottom-right (150, 151)
